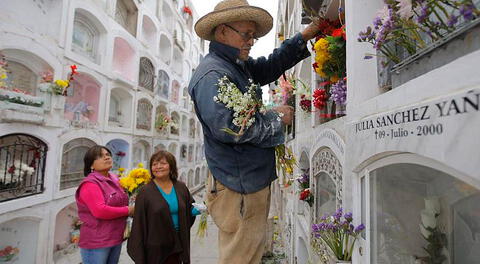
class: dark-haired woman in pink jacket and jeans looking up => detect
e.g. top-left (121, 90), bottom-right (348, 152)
top-left (75, 146), bottom-right (133, 264)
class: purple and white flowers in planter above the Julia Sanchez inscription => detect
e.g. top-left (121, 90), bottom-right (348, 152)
top-left (358, 0), bottom-right (480, 63)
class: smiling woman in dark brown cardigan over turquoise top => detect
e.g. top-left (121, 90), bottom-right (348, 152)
top-left (127, 151), bottom-right (200, 264)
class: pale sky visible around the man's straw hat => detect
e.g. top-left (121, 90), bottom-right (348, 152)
top-left (192, 0), bottom-right (278, 58)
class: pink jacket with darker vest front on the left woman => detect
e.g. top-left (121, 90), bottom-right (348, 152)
top-left (75, 172), bottom-right (128, 249)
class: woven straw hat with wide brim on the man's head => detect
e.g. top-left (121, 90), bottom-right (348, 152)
top-left (195, 0), bottom-right (273, 41)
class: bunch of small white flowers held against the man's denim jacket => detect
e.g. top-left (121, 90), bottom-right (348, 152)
top-left (213, 76), bottom-right (297, 179)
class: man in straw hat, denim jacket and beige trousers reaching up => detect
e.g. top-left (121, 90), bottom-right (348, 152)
top-left (189, 0), bottom-right (319, 264)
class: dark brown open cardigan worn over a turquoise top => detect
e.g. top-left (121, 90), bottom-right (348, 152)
top-left (127, 181), bottom-right (195, 264)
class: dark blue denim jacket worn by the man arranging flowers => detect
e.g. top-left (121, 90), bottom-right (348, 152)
top-left (188, 33), bottom-right (310, 194)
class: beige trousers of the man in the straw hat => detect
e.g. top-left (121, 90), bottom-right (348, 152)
top-left (206, 175), bottom-right (270, 264)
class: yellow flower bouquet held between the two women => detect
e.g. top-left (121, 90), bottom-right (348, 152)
top-left (119, 163), bottom-right (151, 239)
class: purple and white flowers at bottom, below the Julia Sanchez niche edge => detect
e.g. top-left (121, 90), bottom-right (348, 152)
top-left (312, 208), bottom-right (365, 261)
